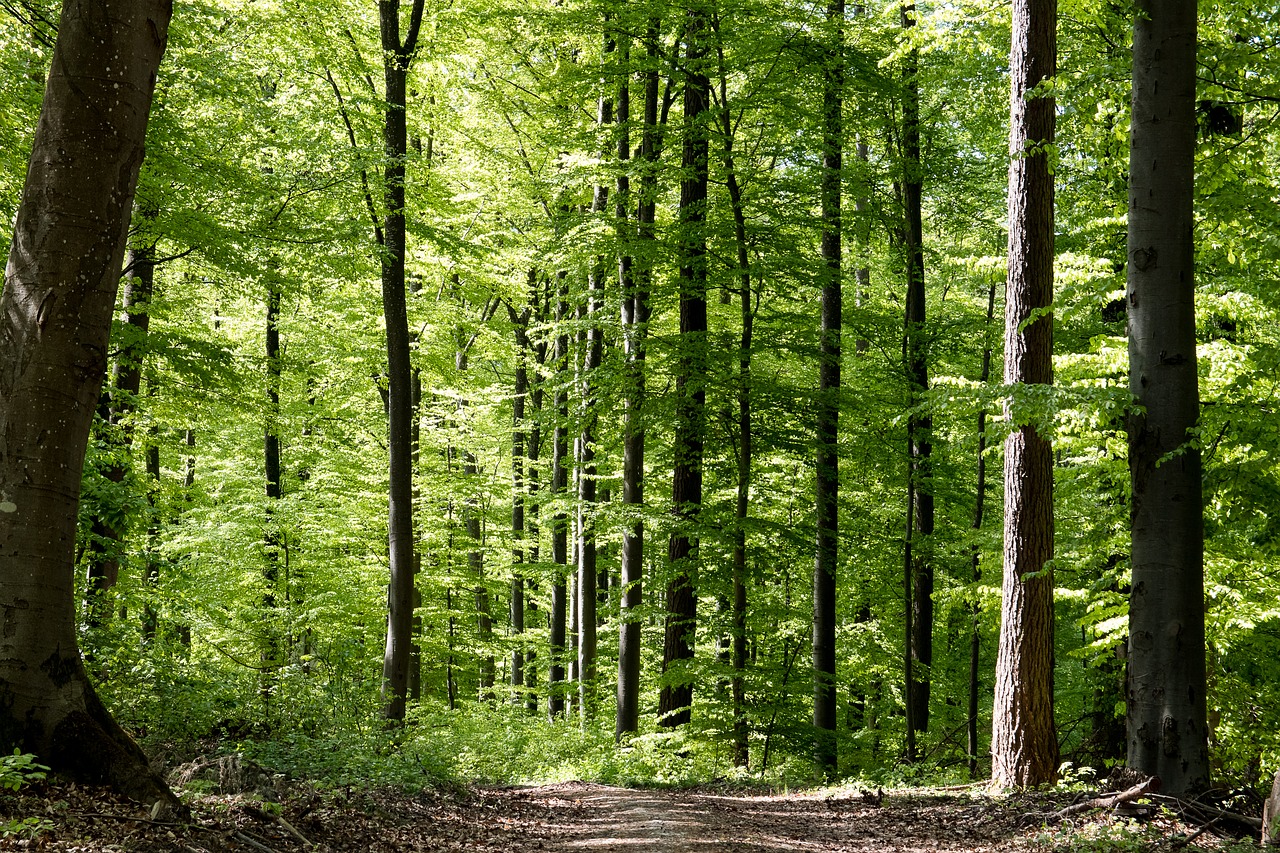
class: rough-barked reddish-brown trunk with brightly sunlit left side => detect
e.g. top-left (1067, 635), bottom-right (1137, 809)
top-left (991, 0), bottom-right (1057, 786)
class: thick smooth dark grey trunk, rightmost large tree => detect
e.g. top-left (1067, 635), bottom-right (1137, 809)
top-left (1126, 0), bottom-right (1210, 794)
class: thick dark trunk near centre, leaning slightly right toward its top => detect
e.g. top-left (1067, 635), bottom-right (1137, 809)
top-left (658, 6), bottom-right (710, 726)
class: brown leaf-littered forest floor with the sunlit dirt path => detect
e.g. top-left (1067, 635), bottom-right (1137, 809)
top-left (0, 783), bottom-right (1259, 853)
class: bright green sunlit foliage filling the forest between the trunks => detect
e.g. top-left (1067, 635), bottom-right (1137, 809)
top-left (0, 0), bottom-right (1280, 799)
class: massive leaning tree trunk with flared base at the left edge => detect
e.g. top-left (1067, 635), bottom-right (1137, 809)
top-left (0, 0), bottom-right (182, 811)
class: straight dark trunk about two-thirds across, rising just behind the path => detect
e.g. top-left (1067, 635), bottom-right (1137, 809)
top-left (813, 0), bottom-right (845, 777)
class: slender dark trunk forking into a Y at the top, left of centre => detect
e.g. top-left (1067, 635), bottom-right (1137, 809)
top-left (378, 0), bottom-right (424, 721)
